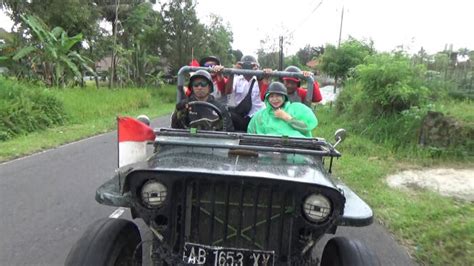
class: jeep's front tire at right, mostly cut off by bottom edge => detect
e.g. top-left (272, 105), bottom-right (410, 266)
top-left (321, 237), bottom-right (380, 266)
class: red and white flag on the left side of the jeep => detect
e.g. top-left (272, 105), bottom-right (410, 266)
top-left (117, 117), bottom-right (155, 167)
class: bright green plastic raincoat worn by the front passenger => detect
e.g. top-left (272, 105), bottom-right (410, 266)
top-left (247, 94), bottom-right (318, 138)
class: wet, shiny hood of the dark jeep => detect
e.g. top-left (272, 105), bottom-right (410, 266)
top-left (142, 147), bottom-right (336, 189)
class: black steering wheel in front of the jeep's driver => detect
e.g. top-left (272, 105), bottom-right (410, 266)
top-left (182, 101), bottom-right (224, 130)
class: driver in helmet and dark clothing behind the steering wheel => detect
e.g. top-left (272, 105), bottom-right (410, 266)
top-left (171, 70), bottom-right (234, 131)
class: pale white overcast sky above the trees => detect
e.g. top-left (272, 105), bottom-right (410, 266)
top-left (0, 0), bottom-right (474, 54)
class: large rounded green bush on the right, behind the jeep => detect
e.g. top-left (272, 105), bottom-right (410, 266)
top-left (336, 53), bottom-right (431, 148)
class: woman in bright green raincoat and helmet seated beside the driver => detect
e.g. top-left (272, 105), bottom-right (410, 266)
top-left (247, 82), bottom-right (318, 138)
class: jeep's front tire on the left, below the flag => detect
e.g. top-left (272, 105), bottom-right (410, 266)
top-left (65, 218), bottom-right (142, 266)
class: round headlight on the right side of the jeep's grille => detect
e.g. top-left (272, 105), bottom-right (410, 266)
top-left (302, 192), bottom-right (333, 224)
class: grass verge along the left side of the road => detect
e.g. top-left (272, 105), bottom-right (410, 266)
top-left (0, 85), bottom-right (176, 161)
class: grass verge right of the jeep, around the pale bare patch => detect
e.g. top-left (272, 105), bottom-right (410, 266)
top-left (314, 106), bottom-right (474, 265)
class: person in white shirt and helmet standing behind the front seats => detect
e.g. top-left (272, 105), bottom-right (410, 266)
top-left (226, 55), bottom-right (265, 132)
